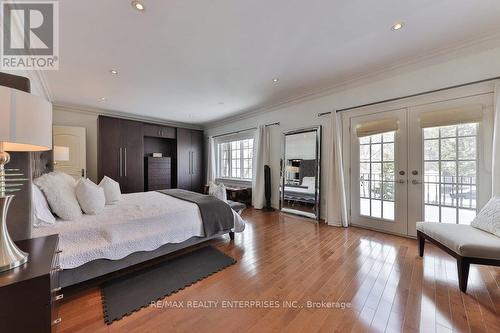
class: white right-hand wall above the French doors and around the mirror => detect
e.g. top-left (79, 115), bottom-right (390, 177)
top-left (205, 47), bottom-right (500, 217)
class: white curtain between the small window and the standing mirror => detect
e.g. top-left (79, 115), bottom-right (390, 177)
top-left (252, 125), bottom-right (269, 209)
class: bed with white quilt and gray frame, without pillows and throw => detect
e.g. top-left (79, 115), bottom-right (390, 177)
top-left (32, 192), bottom-right (245, 287)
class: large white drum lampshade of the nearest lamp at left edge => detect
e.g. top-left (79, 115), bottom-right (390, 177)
top-left (0, 86), bottom-right (52, 151)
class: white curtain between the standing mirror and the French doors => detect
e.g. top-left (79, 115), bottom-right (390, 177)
top-left (326, 111), bottom-right (349, 227)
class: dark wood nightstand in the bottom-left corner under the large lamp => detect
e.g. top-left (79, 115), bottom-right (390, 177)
top-left (0, 235), bottom-right (63, 333)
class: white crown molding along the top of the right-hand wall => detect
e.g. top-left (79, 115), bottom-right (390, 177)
top-left (202, 33), bottom-right (500, 130)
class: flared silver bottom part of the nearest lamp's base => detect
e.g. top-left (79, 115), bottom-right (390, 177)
top-left (0, 195), bottom-right (28, 272)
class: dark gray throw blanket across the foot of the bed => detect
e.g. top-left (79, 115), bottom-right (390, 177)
top-left (158, 189), bottom-right (234, 237)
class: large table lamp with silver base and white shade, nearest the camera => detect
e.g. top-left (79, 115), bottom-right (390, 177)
top-left (0, 86), bottom-right (52, 272)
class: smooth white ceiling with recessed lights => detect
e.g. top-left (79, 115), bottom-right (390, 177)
top-left (45, 0), bottom-right (500, 124)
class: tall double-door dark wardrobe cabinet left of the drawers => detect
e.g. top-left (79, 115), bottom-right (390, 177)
top-left (97, 116), bottom-right (144, 193)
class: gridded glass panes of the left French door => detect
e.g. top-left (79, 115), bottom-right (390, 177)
top-left (359, 131), bottom-right (395, 221)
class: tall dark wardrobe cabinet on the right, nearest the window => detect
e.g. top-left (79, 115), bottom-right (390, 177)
top-left (177, 128), bottom-right (203, 192)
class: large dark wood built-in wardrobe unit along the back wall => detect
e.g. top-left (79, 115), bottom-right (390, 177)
top-left (98, 116), bottom-right (204, 193)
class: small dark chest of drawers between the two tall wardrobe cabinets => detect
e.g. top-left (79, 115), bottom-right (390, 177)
top-left (144, 156), bottom-right (172, 191)
